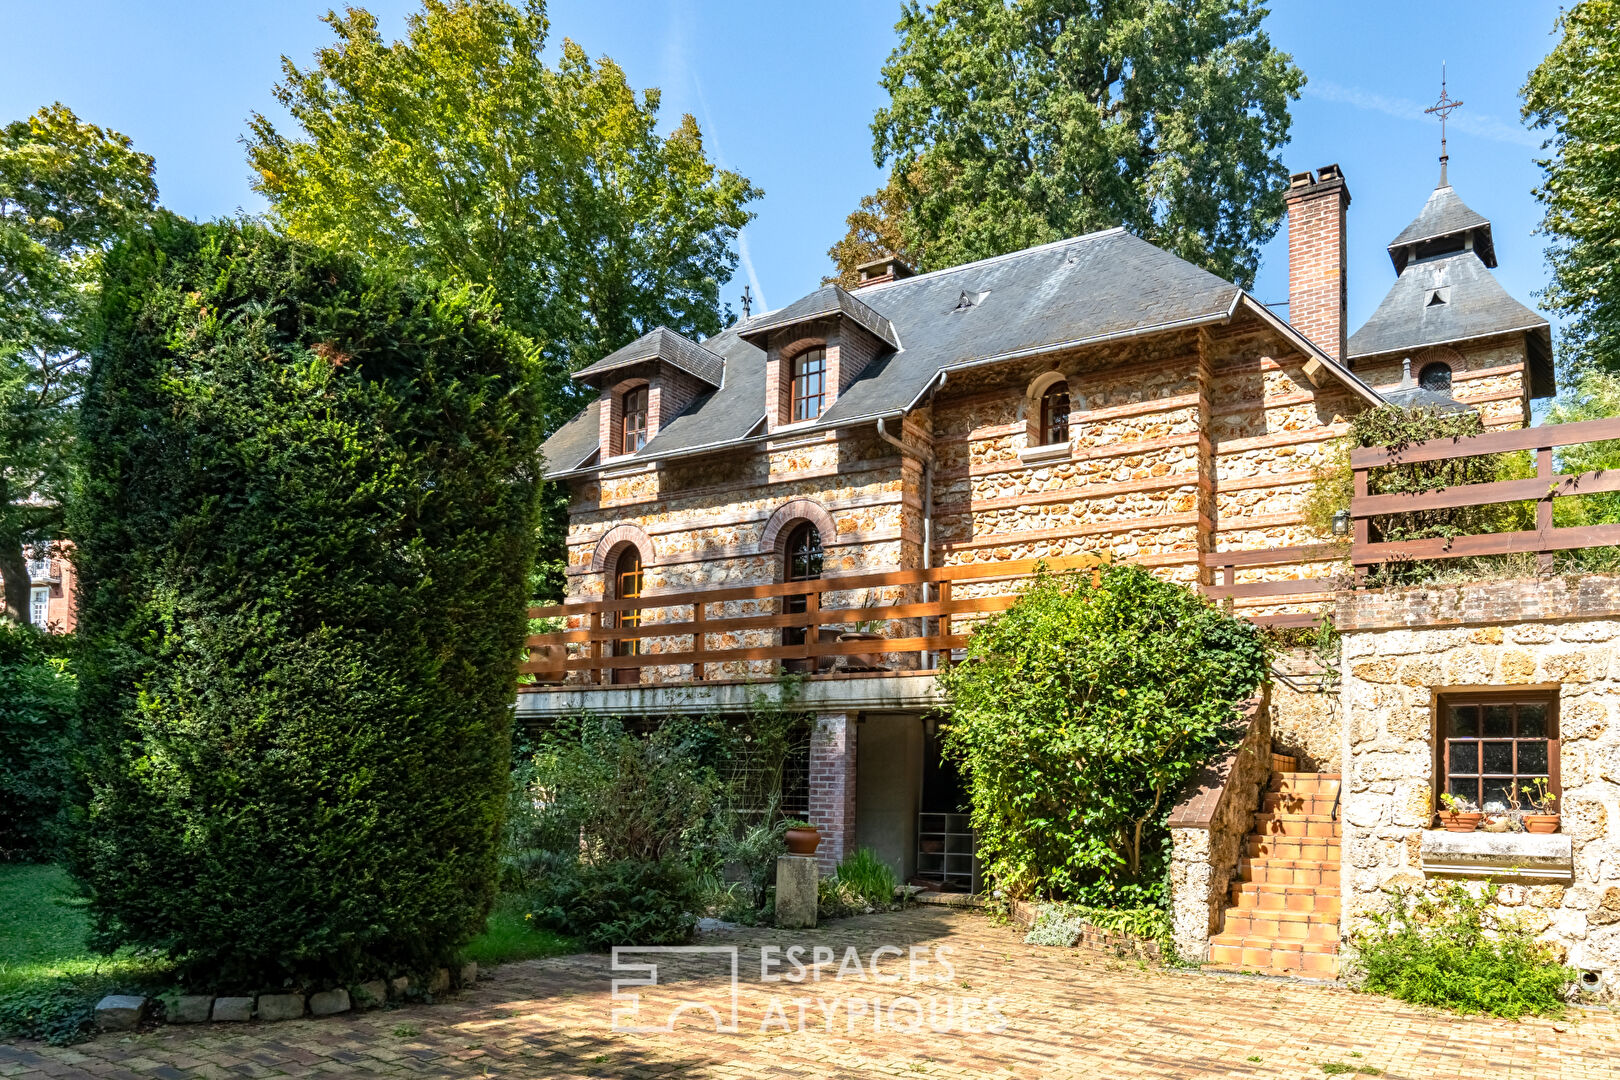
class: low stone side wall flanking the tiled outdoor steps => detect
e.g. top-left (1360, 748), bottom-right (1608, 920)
top-left (1170, 696), bottom-right (1272, 962)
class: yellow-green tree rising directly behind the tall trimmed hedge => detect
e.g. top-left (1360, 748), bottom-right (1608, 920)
top-left (248, 0), bottom-right (761, 440)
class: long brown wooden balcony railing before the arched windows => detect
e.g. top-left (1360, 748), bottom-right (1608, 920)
top-left (518, 555), bottom-right (1103, 683)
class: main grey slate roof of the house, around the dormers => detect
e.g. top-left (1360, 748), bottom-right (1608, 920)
top-left (544, 228), bottom-right (1377, 476)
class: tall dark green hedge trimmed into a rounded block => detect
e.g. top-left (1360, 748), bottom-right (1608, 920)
top-left (70, 220), bottom-right (541, 986)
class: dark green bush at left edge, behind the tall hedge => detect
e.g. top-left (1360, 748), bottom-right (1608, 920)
top-left (0, 620), bottom-right (75, 861)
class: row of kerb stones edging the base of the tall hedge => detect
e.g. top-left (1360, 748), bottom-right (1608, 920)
top-left (96, 962), bottom-right (478, 1031)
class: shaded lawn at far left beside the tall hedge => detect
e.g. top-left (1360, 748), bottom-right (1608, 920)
top-left (0, 865), bottom-right (167, 1044)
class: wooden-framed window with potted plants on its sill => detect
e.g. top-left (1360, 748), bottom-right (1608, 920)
top-left (1435, 691), bottom-right (1562, 810)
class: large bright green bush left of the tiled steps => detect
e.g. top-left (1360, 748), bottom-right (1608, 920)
top-left (940, 567), bottom-right (1267, 907)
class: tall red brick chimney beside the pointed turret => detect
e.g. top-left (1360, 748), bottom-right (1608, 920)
top-left (1286, 165), bottom-right (1349, 359)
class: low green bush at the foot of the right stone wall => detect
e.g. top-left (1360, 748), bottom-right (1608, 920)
top-left (1353, 884), bottom-right (1575, 1017)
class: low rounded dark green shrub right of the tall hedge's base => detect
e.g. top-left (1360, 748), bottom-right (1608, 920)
top-left (531, 858), bottom-right (698, 949)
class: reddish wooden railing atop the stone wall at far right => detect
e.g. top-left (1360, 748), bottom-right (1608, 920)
top-left (1349, 418), bottom-right (1620, 581)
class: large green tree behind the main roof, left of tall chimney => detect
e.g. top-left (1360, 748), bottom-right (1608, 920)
top-left (872, 0), bottom-right (1304, 287)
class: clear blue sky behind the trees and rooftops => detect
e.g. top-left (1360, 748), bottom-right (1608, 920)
top-left (0, 0), bottom-right (1558, 338)
